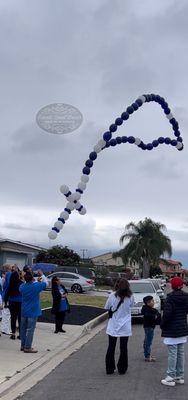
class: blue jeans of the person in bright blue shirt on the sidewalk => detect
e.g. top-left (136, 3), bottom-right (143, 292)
top-left (20, 317), bottom-right (37, 349)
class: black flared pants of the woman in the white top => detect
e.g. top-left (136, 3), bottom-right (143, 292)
top-left (106, 335), bottom-right (128, 374)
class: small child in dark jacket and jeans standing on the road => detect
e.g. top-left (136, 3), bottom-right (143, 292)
top-left (142, 296), bottom-right (161, 362)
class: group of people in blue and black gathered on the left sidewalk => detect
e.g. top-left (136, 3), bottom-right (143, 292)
top-left (0, 265), bottom-right (70, 353)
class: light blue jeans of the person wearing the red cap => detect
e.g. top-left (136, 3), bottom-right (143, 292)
top-left (167, 343), bottom-right (184, 378)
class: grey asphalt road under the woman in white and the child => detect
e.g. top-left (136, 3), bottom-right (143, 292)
top-left (17, 324), bottom-right (188, 400)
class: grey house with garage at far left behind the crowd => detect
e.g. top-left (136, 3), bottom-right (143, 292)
top-left (0, 239), bottom-right (44, 269)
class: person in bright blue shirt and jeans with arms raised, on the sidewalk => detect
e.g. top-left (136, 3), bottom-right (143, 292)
top-left (19, 271), bottom-right (46, 353)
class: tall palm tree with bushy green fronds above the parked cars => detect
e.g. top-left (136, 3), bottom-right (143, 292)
top-left (114, 218), bottom-right (172, 278)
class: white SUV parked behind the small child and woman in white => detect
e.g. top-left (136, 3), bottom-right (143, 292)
top-left (129, 279), bottom-right (161, 317)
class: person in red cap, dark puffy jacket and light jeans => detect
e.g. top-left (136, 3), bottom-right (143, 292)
top-left (161, 277), bottom-right (188, 386)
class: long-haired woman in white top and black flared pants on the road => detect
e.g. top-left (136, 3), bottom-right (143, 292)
top-left (105, 279), bottom-right (134, 375)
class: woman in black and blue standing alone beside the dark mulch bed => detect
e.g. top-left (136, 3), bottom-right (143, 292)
top-left (52, 276), bottom-right (69, 333)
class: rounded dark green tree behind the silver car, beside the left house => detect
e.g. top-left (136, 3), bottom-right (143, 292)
top-left (36, 246), bottom-right (80, 266)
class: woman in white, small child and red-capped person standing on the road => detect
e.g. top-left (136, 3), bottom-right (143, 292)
top-left (105, 277), bottom-right (188, 386)
